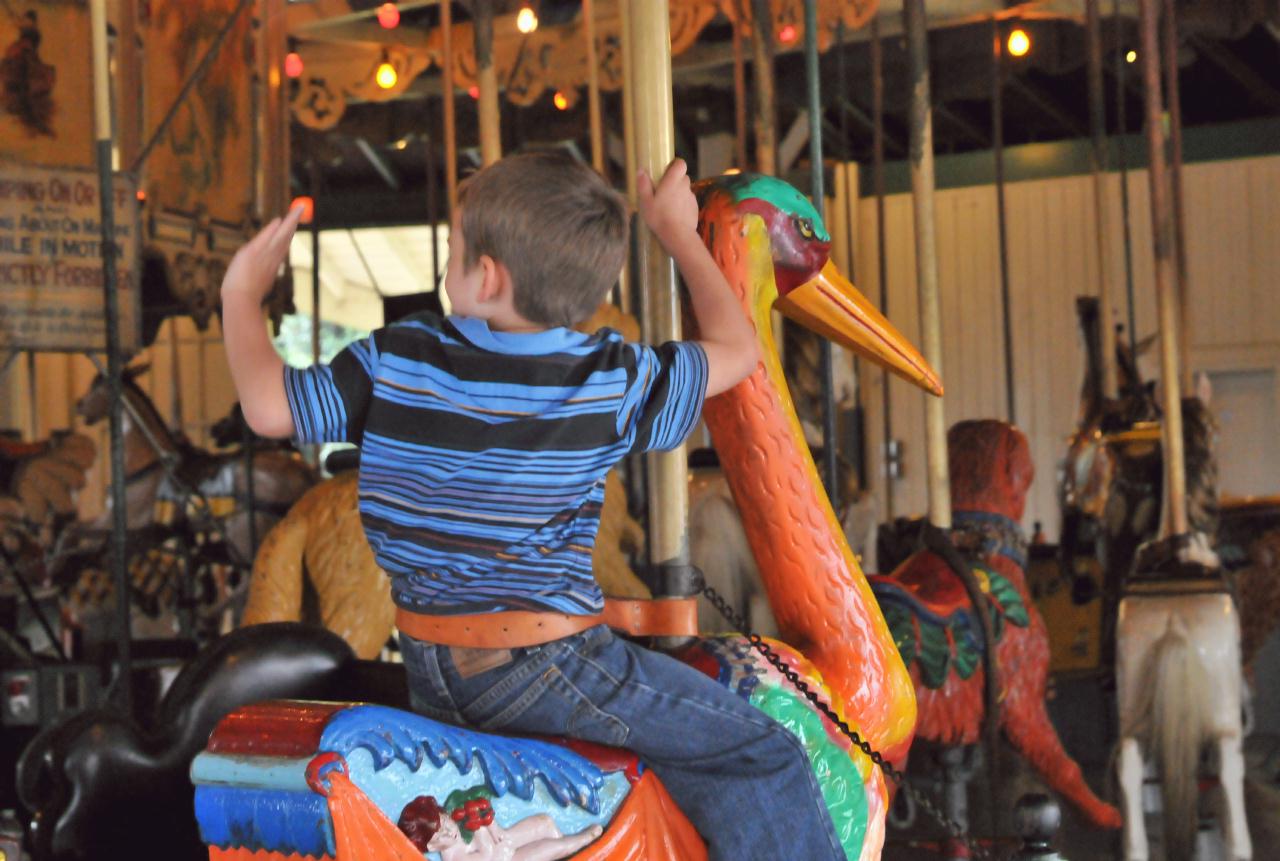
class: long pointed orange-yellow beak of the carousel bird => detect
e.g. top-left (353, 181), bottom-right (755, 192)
top-left (773, 261), bottom-right (942, 397)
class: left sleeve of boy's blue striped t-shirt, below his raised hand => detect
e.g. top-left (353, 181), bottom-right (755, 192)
top-left (284, 336), bottom-right (378, 445)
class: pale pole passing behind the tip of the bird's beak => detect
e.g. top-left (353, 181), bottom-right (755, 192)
top-left (904, 0), bottom-right (951, 530)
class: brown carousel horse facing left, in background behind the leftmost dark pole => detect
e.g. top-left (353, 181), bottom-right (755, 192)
top-left (72, 365), bottom-right (315, 624)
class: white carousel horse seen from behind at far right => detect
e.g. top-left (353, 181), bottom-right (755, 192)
top-left (1116, 533), bottom-right (1253, 861)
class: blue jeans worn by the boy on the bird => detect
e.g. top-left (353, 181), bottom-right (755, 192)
top-left (401, 624), bottom-right (845, 861)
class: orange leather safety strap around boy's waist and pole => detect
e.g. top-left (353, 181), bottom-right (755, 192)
top-left (396, 597), bottom-right (698, 649)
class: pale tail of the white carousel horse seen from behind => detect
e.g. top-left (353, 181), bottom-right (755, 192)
top-left (1134, 614), bottom-right (1213, 861)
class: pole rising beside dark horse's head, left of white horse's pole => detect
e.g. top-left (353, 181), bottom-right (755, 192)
top-left (1084, 0), bottom-right (1116, 398)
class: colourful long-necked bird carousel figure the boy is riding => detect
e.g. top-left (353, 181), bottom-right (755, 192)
top-left (175, 175), bottom-right (941, 861)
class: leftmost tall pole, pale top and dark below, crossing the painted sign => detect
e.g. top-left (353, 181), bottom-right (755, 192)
top-left (90, 0), bottom-right (133, 714)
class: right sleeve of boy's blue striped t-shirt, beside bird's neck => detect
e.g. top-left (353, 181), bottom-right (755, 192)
top-left (631, 340), bottom-right (707, 452)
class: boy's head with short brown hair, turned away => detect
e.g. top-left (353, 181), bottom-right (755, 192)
top-left (445, 152), bottom-right (630, 326)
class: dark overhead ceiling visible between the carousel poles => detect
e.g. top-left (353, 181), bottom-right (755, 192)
top-left (289, 0), bottom-right (1280, 225)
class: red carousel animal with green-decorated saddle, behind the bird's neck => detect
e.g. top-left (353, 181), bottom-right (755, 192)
top-left (870, 420), bottom-right (1120, 828)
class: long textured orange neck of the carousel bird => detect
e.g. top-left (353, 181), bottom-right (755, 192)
top-left (704, 219), bottom-right (915, 757)
